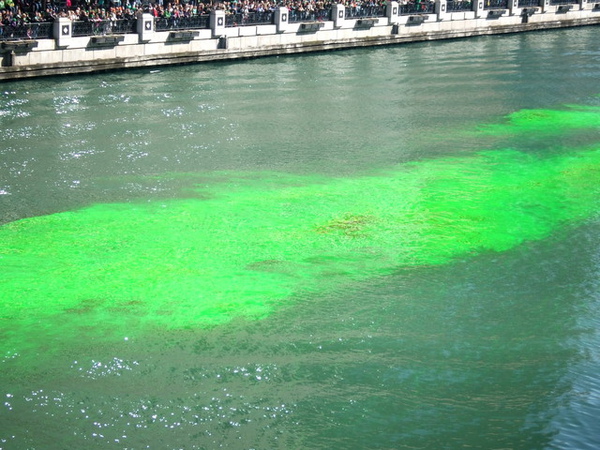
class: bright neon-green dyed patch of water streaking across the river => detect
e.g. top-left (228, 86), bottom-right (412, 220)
top-left (0, 103), bottom-right (600, 351)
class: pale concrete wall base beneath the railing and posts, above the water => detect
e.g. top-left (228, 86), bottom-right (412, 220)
top-left (0, 14), bottom-right (600, 80)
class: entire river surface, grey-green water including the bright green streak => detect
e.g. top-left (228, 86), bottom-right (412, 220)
top-left (0, 27), bottom-right (600, 449)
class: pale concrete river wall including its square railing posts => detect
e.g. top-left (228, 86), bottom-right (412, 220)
top-left (0, 0), bottom-right (600, 80)
